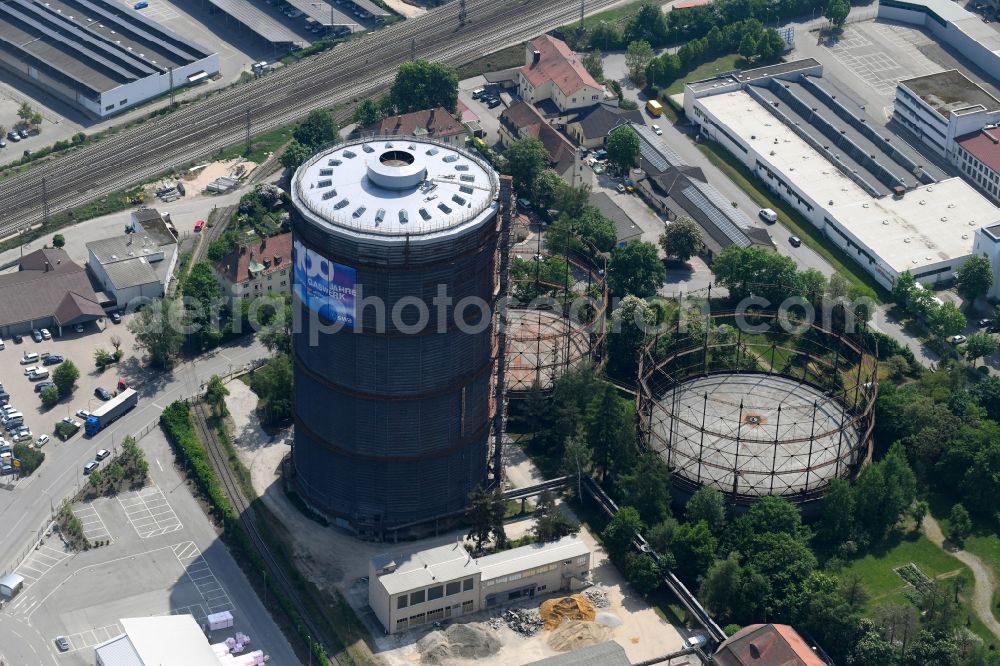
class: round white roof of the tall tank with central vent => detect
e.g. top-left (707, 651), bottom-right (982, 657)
top-left (292, 136), bottom-right (499, 240)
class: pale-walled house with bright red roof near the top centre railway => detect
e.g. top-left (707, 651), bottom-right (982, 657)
top-left (517, 35), bottom-right (605, 113)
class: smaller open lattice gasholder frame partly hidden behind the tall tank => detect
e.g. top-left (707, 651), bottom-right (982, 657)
top-left (505, 218), bottom-right (608, 398)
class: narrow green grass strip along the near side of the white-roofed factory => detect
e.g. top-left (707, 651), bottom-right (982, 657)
top-left (698, 140), bottom-right (889, 302)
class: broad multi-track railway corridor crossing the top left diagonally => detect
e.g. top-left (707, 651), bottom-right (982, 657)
top-left (0, 0), bottom-right (620, 237)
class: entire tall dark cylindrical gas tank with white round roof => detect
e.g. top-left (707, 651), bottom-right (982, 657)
top-left (291, 136), bottom-right (502, 536)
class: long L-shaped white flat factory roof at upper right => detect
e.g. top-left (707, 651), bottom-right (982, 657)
top-left (698, 91), bottom-right (1000, 272)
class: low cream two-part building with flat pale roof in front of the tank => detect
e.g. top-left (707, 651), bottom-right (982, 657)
top-left (368, 536), bottom-right (590, 634)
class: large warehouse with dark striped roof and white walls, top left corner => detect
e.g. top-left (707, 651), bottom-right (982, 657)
top-left (0, 0), bottom-right (219, 118)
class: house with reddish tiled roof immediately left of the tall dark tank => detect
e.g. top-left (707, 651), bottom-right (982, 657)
top-left (214, 233), bottom-right (292, 306)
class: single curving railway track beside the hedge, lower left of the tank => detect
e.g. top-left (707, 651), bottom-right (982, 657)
top-left (191, 401), bottom-right (340, 664)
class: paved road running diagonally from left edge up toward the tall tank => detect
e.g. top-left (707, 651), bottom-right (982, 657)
top-left (0, 338), bottom-right (267, 572)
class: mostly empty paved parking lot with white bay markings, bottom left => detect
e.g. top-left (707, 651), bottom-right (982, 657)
top-left (0, 422), bottom-right (300, 666)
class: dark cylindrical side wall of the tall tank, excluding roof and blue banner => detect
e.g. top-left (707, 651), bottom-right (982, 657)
top-left (292, 135), bottom-right (500, 537)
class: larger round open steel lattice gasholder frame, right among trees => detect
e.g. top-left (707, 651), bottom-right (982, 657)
top-left (637, 312), bottom-right (878, 506)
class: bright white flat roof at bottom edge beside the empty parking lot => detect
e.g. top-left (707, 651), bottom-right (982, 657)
top-left (96, 615), bottom-right (219, 666)
